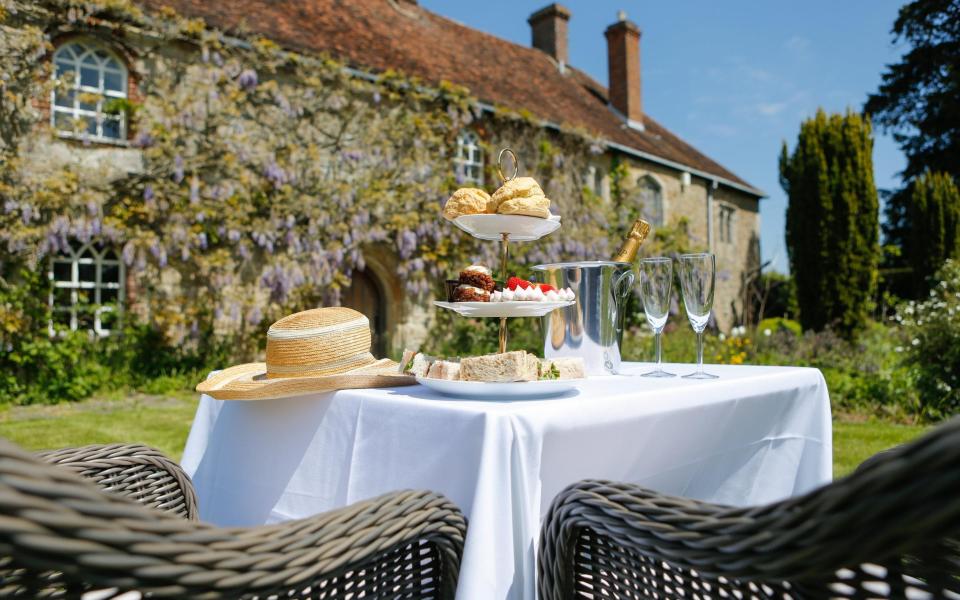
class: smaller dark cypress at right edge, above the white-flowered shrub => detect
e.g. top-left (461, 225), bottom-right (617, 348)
top-left (903, 171), bottom-right (960, 296)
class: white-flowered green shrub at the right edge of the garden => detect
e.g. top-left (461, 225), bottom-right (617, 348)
top-left (894, 260), bottom-right (960, 419)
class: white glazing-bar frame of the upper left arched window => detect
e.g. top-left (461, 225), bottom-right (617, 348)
top-left (50, 38), bottom-right (129, 145)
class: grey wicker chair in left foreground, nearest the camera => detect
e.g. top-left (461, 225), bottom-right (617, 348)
top-left (0, 440), bottom-right (466, 599)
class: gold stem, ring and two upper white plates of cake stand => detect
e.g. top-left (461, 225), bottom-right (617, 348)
top-left (434, 148), bottom-right (574, 353)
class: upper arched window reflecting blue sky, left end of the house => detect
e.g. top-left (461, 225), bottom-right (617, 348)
top-left (50, 40), bottom-right (127, 142)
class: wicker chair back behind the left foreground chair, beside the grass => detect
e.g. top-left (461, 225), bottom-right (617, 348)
top-left (37, 444), bottom-right (197, 520)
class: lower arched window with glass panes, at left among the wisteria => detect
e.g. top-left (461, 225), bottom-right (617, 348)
top-left (49, 242), bottom-right (124, 336)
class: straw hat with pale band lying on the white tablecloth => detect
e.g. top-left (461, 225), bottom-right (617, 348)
top-left (197, 307), bottom-right (416, 400)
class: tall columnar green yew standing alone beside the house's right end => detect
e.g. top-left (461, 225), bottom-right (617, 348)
top-left (780, 109), bottom-right (879, 338)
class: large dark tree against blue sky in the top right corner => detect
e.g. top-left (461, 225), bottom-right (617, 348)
top-left (864, 0), bottom-right (960, 180)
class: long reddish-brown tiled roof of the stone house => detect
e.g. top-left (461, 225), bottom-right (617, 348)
top-left (139, 0), bottom-right (761, 195)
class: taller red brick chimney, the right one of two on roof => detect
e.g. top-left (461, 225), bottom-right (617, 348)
top-left (604, 11), bottom-right (643, 129)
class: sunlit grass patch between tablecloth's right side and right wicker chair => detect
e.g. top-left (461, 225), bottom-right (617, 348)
top-left (833, 420), bottom-right (928, 477)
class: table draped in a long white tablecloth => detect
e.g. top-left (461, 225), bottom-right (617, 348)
top-left (182, 363), bottom-right (832, 600)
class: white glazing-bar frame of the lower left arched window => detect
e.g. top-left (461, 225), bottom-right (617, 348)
top-left (47, 242), bottom-right (126, 337)
